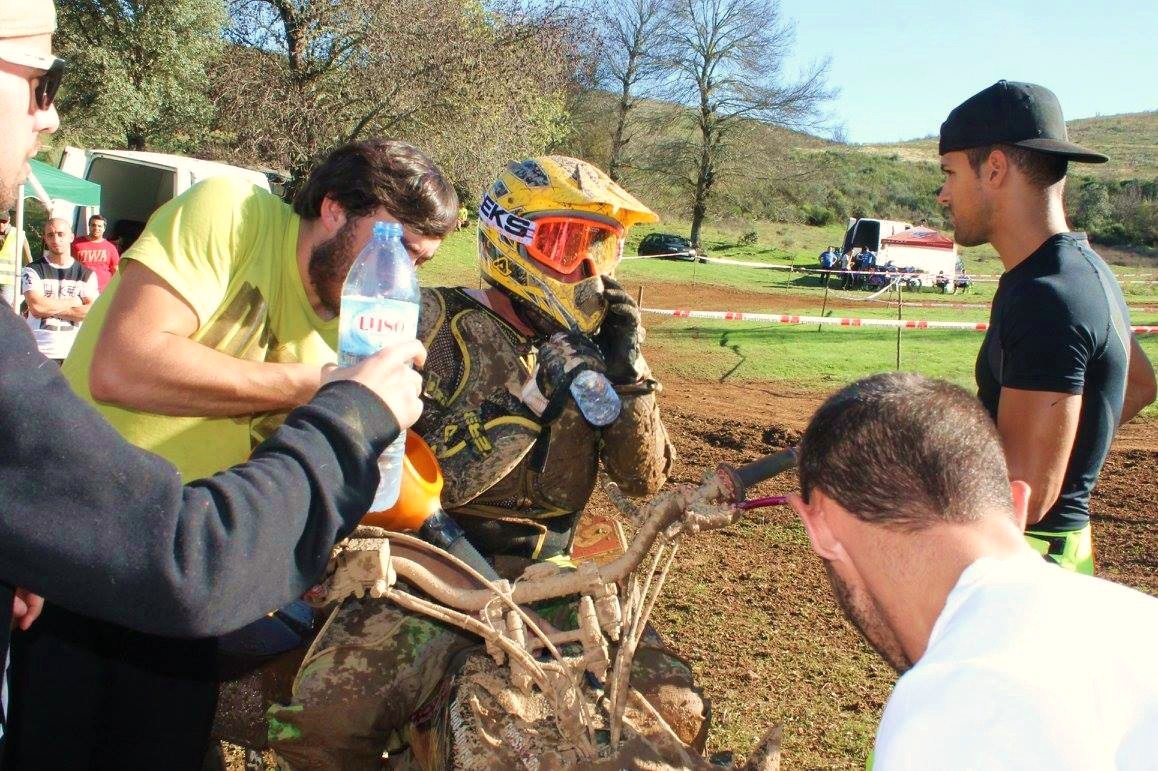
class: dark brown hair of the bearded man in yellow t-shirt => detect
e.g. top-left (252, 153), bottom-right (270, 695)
top-left (293, 139), bottom-right (459, 238)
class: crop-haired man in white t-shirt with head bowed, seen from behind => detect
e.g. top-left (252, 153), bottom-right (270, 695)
top-left (792, 373), bottom-right (1158, 771)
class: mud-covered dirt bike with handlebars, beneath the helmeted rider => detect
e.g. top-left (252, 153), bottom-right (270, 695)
top-left (215, 449), bottom-right (796, 771)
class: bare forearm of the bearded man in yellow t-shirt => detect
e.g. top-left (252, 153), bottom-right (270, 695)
top-left (90, 333), bottom-right (322, 417)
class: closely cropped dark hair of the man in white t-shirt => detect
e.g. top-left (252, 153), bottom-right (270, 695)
top-left (799, 373), bottom-right (1013, 530)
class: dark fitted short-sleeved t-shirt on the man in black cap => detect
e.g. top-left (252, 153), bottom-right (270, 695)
top-left (976, 233), bottom-right (1130, 533)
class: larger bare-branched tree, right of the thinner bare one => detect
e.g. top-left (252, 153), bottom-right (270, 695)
top-left (660, 0), bottom-right (833, 245)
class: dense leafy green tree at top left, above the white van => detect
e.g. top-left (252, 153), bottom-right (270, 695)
top-left (56, 0), bottom-right (226, 152)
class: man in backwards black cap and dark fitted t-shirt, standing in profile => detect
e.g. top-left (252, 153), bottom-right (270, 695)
top-left (938, 80), bottom-right (1155, 573)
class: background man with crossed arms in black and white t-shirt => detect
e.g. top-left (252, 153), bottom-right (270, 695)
top-left (20, 218), bottom-right (100, 364)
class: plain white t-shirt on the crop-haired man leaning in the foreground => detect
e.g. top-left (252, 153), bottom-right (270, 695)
top-left (873, 556), bottom-right (1158, 771)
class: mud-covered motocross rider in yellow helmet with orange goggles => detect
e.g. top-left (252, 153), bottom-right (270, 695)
top-left (267, 156), bottom-right (708, 769)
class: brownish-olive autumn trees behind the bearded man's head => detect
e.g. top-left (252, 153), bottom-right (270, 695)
top-left (213, 0), bottom-right (571, 191)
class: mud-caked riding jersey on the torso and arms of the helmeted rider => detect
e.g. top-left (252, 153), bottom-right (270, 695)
top-left (415, 288), bottom-right (672, 559)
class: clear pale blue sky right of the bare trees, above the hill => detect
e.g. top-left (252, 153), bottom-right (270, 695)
top-left (780, 0), bottom-right (1158, 142)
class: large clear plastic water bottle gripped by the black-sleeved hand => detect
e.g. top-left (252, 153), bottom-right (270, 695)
top-left (338, 221), bottom-right (422, 512)
